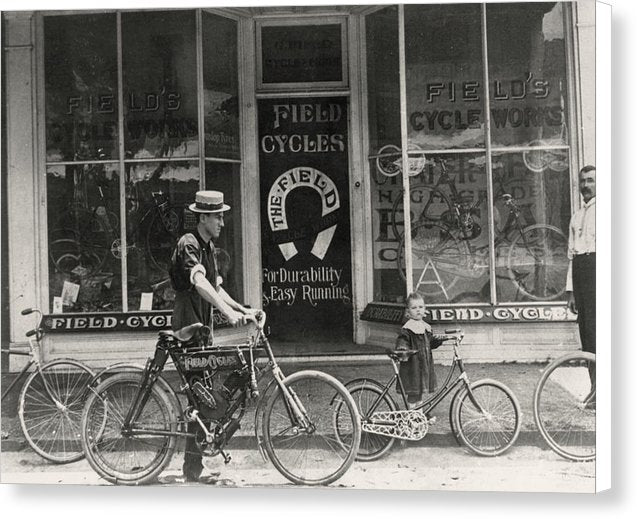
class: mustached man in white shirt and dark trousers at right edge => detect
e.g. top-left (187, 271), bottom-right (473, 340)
top-left (566, 166), bottom-right (596, 394)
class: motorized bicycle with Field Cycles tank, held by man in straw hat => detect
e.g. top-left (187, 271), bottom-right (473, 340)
top-left (81, 312), bottom-right (361, 485)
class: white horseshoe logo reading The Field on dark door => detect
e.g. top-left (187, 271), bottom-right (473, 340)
top-left (268, 167), bottom-right (341, 261)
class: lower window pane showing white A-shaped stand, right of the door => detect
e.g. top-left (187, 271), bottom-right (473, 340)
top-left (391, 154), bottom-right (490, 303)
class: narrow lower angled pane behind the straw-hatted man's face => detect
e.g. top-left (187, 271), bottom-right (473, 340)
top-left (205, 161), bottom-right (243, 301)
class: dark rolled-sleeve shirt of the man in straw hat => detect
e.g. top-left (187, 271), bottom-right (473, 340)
top-left (170, 229), bottom-right (219, 330)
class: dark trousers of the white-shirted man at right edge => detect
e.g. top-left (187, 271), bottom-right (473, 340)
top-left (573, 253), bottom-right (596, 384)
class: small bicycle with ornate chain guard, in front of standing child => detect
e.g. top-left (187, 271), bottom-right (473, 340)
top-left (335, 329), bottom-right (521, 461)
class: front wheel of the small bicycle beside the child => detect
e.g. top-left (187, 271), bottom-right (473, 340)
top-left (451, 379), bottom-right (521, 456)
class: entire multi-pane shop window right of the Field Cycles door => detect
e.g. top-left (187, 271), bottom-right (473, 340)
top-left (366, 2), bottom-right (571, 305)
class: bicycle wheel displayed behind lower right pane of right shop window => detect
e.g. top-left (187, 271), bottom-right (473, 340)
top-left (507, 224), bottom-right (568, 301)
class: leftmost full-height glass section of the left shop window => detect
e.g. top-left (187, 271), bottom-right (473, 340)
top-left (44, 14), bottom-right (122, 313)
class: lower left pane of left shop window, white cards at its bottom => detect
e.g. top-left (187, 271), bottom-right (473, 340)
top-left (46, 164), bottom-right (121, 313)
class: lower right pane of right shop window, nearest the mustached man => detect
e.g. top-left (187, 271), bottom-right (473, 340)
top-left (493, 153), bottom-right (570, 302)
